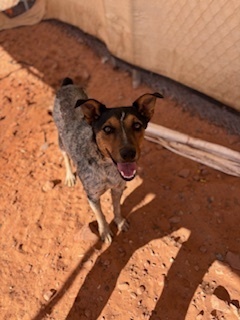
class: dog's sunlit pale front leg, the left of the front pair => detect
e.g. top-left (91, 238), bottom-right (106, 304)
top-left (88, 198), bottom-right (112, 243)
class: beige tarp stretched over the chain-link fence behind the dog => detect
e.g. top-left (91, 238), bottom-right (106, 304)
top-left (0, 0), bottom-right (240, 110)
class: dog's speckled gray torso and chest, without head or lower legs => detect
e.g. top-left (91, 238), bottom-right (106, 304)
top-left (53, 85), bottom-right (125, 201)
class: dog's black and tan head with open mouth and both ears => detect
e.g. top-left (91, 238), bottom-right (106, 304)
top-left (76, 93), bottom-right (163, 181)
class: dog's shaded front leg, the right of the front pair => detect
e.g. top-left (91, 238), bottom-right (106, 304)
top-left (111, 189), bottom-right (129, 231)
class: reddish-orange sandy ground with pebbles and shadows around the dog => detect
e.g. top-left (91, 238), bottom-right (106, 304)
top-left (0, 22), bottom-right (240, 320)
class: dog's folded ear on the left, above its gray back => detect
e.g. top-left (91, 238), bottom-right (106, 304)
top-left (75, 99), bottom-right (106, 124)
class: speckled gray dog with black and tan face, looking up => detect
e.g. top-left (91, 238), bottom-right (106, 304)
top-left (53, 78), bottom-right (163, 243)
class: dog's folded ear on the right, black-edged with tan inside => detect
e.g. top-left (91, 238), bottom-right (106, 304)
top-left (133, 92), bottom-right (163, 121)
